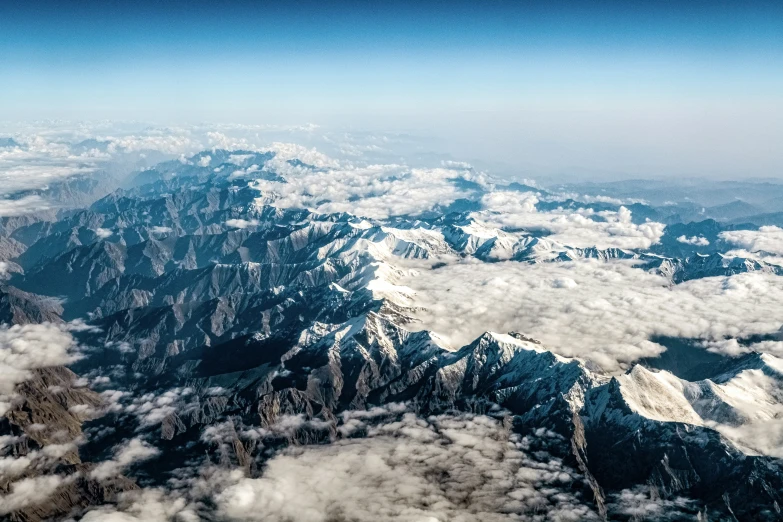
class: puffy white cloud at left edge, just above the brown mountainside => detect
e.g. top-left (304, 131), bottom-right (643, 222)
top-left (0, 323), bottom-right (79, 415)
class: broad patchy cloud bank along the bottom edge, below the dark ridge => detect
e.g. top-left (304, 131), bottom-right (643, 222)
top-left (76, 405), bottom-right (600, 522)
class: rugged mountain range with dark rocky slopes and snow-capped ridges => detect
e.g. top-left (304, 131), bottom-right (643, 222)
top-left (0, 150), bottom-right (783, 521)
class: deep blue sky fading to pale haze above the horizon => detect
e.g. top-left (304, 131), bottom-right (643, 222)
top-left (0, 0), bottom-right (783, 178)
